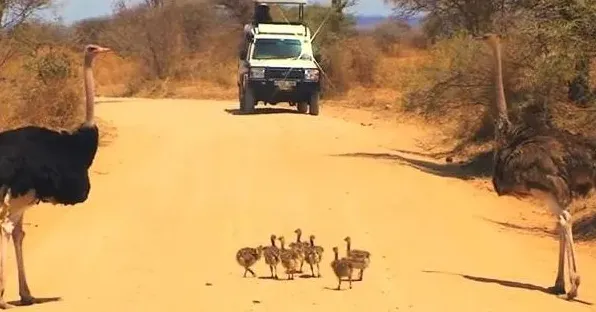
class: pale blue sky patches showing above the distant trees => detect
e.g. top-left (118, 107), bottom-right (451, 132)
top-left (56, 0), bottom-right (391, 23)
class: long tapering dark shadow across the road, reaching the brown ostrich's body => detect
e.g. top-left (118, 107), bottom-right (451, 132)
top-left (332, 152), bottom-right (493, 180)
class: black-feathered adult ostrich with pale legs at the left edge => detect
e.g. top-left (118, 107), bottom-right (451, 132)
top-left (0, 45), bottom-right (110, 309)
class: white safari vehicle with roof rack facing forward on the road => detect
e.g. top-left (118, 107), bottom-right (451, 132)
top-left (238, 0), bottom-right (321, 115)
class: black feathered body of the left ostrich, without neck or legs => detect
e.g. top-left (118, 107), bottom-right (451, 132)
top-left (0, 126), bottom-right (99, 205)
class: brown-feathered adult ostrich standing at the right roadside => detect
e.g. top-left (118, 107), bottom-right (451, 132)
top-left (483, 34), bottom-right (596, 300)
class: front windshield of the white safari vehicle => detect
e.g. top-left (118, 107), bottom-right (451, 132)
top-left (252, 38), bottom-right (302, 60)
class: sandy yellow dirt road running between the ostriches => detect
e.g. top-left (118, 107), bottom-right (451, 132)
top-left (5, 99), bottom-right (596, 312)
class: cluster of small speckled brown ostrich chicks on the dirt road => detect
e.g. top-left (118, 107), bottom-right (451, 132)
top-left (236, 228), bottom-right (370, 290)
